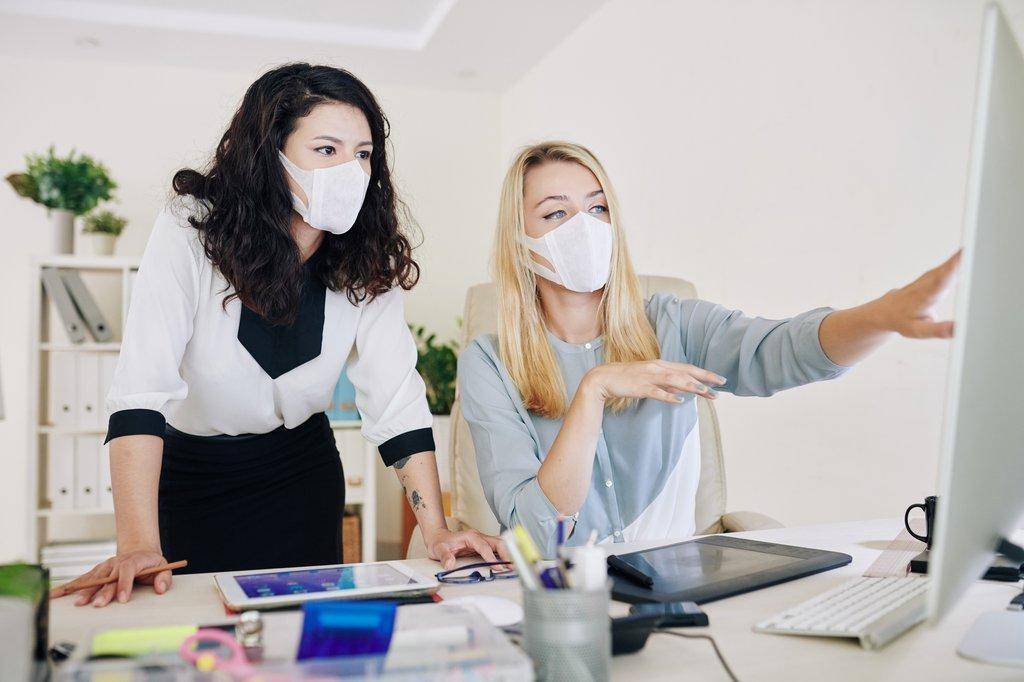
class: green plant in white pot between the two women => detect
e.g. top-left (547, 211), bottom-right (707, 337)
top-left (412, 327), bottom-right (459, 491)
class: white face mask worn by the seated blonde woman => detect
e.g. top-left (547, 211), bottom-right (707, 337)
top-left (522, 212), bottom-right (614, 293)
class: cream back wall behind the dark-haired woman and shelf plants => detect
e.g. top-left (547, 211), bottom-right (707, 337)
top-left (0, 57), bottom-right (500, 561)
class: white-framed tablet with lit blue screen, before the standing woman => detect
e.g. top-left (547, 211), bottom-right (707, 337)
top-left (214, 561), bottom-right (438, 609)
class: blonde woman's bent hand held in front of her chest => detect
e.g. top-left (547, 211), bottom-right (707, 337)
top-left (581, 359), bottom-right (725, 402)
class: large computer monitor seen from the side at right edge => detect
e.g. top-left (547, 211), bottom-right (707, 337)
top-left (929, 4), bottom-right (1024, 665)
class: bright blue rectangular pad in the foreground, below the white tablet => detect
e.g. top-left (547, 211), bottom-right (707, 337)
top-left (297, 601), bottom-right (397, 660)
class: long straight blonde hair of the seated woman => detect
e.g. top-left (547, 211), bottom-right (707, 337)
top-left (494, 141), bottom-right (660, 419)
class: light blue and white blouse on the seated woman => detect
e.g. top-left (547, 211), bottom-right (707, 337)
top-left (459, 294), bottom-right (847, 556)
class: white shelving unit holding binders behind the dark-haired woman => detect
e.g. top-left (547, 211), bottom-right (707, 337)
top-left (27, 255), bottom-right (377, 561)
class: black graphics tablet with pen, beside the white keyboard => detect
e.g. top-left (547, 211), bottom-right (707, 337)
top-left (608, 536), bottom-right (853, 604)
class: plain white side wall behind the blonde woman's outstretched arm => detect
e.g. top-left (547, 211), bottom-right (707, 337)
top-left (502, 0), bottom-right (1007, 524)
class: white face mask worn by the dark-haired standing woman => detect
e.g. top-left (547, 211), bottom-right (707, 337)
top-left (278, 152), bottom-right (370, 235)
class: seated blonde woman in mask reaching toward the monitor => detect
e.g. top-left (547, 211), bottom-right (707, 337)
top-left (459, 142), bottom-right (957, 555)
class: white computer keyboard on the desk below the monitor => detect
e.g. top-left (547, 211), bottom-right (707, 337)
top-left (754, 576), bottom-right (928, 649)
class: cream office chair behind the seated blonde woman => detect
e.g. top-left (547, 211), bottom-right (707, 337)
top-left (407, 275), bottom-right (782, 559)
